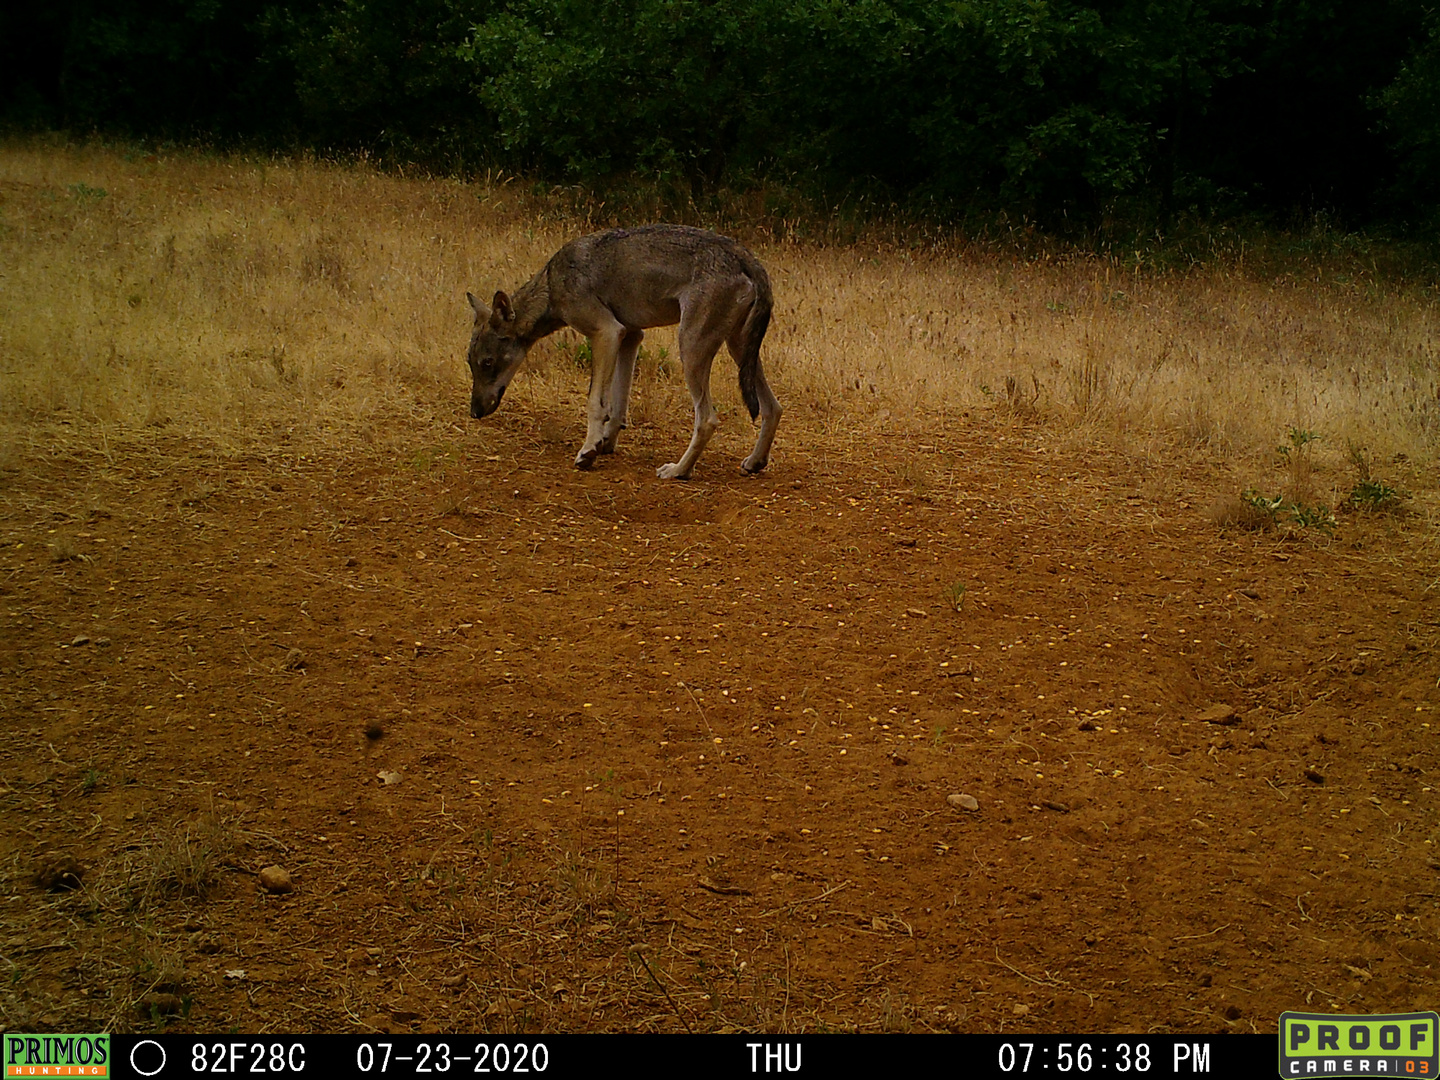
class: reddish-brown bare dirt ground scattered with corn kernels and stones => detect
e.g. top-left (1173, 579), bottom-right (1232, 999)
top-left (0, 397), bottom-right (1440, 1034)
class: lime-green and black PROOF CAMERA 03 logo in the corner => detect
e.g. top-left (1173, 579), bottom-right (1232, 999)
top-left (1280, 1012), bottom-right (1440, 1079)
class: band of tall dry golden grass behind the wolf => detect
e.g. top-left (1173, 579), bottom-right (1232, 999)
top-left (0, 143), bottom-right (1440, 458)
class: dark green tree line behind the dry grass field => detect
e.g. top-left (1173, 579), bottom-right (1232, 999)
top-left (0, 0), bottom-right (1440, 229)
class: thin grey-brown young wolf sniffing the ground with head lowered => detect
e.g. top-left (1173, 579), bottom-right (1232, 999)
top-left (465, 225), bottom-right (780, 480)
